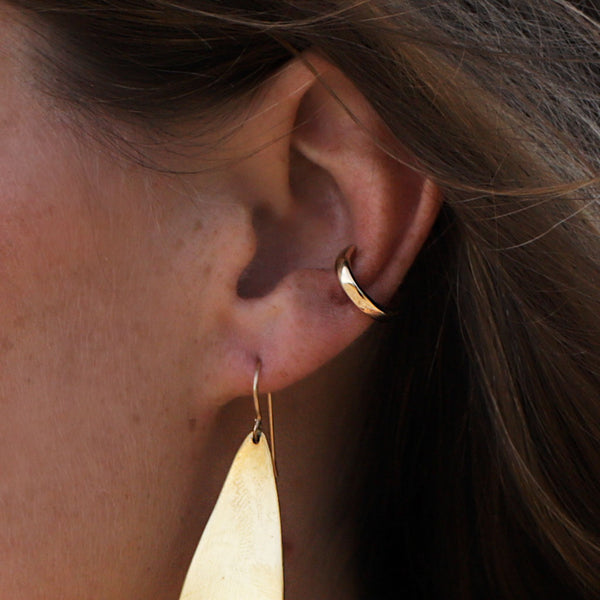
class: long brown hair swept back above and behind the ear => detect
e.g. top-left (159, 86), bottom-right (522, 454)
top-left (5, 0), bottom-right (600, 599)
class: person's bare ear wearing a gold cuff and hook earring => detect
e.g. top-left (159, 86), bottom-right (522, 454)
top-left (211, 53), bottom-right (440, 394)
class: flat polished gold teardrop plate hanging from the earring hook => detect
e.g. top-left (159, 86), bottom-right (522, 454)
top-left (180, 433), bottom-right (283, 600)
